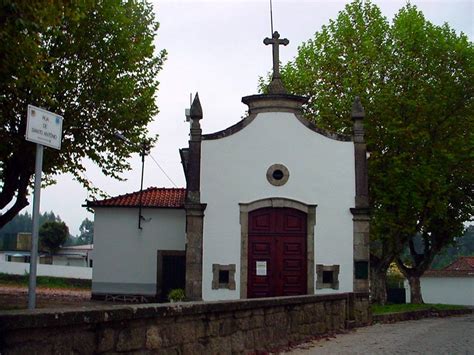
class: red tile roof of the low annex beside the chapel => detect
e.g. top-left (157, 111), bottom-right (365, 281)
top-left (85, 187), bottom-right (186, 208)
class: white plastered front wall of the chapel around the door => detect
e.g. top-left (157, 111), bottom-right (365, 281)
top-left (201, 112), bottom-right (355, 300)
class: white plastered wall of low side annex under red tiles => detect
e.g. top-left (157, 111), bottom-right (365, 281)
top-left (92, 207), bottom-right (186, 295)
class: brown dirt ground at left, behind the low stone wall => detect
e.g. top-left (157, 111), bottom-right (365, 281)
top-left (0, 285), bottom-right (104, 310)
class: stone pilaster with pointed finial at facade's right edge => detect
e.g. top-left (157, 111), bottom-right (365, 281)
top-left (351, 97), bottom-right (370, 292)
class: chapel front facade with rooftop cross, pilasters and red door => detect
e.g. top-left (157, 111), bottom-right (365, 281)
top-left (181, 32), bottom-right (369, 300)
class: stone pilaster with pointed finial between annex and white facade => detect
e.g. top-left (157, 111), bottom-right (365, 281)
top-left (184, 94), bottom-right (206, 301)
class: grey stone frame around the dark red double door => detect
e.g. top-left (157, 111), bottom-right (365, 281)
top-left (239, 197), bottom-right (317, 298)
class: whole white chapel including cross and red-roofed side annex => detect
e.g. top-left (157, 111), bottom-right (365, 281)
top-left (86, 32), bottom-right (369, 301)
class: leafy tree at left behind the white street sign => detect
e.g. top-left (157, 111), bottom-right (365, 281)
top-left (0, 0), bottom-right (166, 228)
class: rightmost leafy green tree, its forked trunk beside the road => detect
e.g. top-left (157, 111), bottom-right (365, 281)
top-left (386, 5), bottom-right (474, 303)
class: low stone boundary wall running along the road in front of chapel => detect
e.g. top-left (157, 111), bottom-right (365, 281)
top-left (0, 293), bottom-right (371, 354)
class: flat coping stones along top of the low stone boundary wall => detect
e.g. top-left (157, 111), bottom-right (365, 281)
top-left (0, 292), bottom-right (368, 331)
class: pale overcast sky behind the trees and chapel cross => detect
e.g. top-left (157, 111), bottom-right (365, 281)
top-left (9, 0), bottom-right (474, 234)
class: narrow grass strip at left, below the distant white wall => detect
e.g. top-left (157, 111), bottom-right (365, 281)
top-left (0, 273), bottom-right (92, 290)
